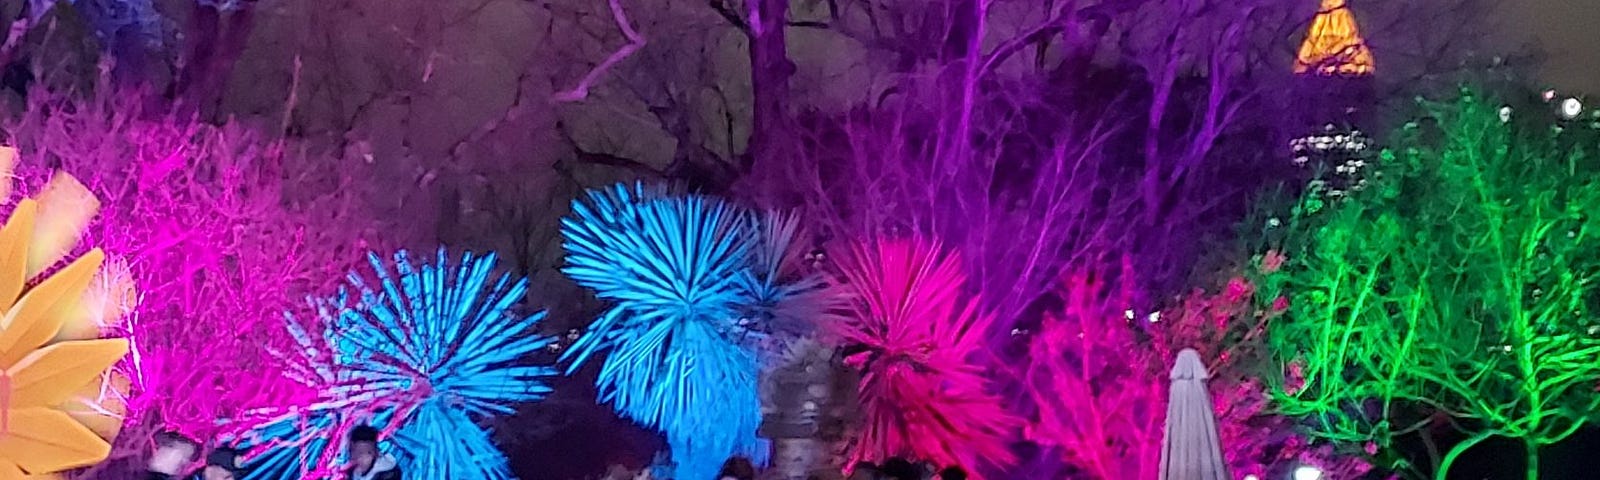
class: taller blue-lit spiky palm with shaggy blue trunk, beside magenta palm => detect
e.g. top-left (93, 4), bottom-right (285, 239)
top-left (562, 184), bottom-right (826, 478)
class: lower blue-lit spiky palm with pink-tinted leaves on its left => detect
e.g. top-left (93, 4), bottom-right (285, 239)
top-left (242, 251), bottom-right (555, 478)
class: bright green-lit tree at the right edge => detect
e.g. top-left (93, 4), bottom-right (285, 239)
top-left (1259, 93), bottom-right (1600, 480)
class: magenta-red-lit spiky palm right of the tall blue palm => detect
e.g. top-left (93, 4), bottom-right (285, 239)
top-left (832, 238), bottom-right (1018, 469)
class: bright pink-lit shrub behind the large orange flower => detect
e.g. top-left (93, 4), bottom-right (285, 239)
top-left (3, 87), bottom-right (371, 473)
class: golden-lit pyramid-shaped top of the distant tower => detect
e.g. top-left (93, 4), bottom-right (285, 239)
top-left (1294, 0), bottom-right (1373, 77)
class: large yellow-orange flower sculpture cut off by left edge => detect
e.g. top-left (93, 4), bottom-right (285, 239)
top-left (0, 160), bottom-right (128, 480)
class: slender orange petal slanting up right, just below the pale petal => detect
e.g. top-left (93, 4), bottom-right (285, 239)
top-left (0, 248), bottom-right (106, 369)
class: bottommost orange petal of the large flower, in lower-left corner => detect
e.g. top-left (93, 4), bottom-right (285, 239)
top-left (0, 408), bottom-right (110, 478)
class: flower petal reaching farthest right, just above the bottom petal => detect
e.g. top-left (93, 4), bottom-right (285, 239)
top-left (6, 338), bottom-right (128, 408)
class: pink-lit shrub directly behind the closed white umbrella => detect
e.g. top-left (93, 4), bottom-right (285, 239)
top-left (1021, 260), bottom-right (1368, 478)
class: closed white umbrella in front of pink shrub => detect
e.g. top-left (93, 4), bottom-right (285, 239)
top-left (1162, 349), bottom-right (1229, 480)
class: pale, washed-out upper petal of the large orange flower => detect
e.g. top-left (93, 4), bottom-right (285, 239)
top-left (27, 171), bottom-right (99, 277)
